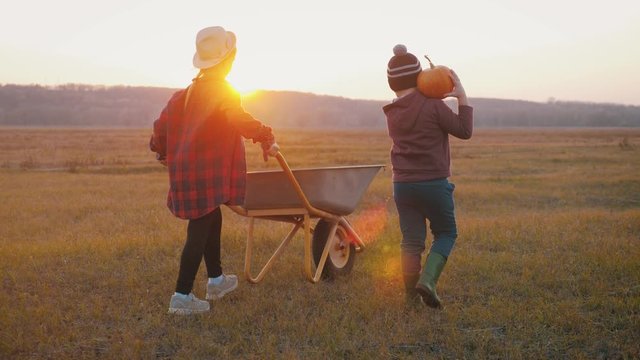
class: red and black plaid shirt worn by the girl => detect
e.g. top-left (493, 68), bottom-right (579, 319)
top-left (150, 76), bottom-right (274, 219)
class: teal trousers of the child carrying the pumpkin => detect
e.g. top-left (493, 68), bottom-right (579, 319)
top-left (393, 178), bottom-right (458, 273)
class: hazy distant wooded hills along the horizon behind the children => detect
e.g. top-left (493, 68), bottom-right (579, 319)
top-left (0, 84), bottom-right (640, 129)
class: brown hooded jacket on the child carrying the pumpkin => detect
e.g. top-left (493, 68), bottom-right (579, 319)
top-left (383, 91), bottom-right (473, 182)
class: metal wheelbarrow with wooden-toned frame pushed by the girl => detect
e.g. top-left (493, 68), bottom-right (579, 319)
top-left (229, 151), bottom-right (384, 284)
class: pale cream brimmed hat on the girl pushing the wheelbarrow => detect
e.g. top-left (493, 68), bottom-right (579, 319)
top-left (193, 26), bottom-right (236, 69)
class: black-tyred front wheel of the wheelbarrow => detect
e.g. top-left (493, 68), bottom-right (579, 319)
top-left (312, 219), bottom-right (356, 280)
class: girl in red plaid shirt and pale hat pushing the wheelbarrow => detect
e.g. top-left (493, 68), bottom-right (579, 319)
top-left (150, 26), bottom-right (276, 314)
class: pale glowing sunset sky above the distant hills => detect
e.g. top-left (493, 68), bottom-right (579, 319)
top-left (0, 0), bottom-right (640, 105)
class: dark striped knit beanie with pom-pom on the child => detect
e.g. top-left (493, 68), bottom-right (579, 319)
top-left (387, 44), bottom-right (422, 91)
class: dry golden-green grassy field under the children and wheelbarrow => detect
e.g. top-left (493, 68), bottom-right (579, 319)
top-left (0, 129), bottom-right (640, 359)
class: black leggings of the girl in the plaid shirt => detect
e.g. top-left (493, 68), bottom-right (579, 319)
top-left (176, 208), bottom-right (222, 294)
